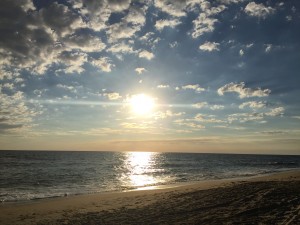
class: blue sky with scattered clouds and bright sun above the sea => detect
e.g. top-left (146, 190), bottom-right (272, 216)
top-left (0, 0), bottom-right (300, 154)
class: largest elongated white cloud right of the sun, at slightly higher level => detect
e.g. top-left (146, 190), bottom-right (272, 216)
top-left (218, 82), bottom-right (271, 98)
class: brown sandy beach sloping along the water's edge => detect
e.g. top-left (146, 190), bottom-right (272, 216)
top-left (0, 170), bottom-right (300, 225)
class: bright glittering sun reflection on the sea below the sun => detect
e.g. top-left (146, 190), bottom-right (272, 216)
top-left (123, 152), bottom-right (159, 187)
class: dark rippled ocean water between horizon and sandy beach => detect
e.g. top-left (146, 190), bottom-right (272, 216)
top-left (0, 151), bottom-right (300, 203)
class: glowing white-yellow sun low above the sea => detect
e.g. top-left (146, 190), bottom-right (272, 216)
top-left (129, 94), bottom-right (155, 116)
